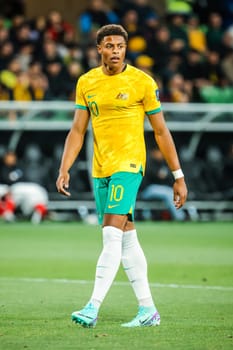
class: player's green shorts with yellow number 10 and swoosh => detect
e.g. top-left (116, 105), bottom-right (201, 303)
top-left (93, 171), bottom-right (143, 224)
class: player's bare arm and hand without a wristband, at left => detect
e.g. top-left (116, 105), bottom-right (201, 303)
top-left (56, 109), bottom-right (89, 196)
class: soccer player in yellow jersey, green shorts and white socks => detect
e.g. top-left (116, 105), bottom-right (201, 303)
top-left (56, 24), bottom-right (187, 327)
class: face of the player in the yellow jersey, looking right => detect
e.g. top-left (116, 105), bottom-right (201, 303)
top-left (97, 35), bottom-right (126, 74)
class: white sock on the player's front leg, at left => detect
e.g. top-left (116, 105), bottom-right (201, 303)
top-left (90, 226), bottom-right (123, 308)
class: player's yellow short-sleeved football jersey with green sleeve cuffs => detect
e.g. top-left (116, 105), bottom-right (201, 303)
top-left (76, 65), bottom-right (161, 177)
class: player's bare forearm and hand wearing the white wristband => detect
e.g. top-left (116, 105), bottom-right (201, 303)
top-left (149, 111), bottom-right (187, 208)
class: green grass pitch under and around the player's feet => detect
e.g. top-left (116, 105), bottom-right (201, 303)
top-left (0, 222), bottom-right (233, 350)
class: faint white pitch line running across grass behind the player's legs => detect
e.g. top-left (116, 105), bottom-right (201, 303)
top-left (0, 277), bottom-right (233, 292)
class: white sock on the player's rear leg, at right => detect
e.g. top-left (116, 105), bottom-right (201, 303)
top-left (122, 230), bottom-right (154, 306)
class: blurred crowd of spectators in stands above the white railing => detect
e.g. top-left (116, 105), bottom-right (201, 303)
top-left (0, 0), bottom-right (233, 107)
